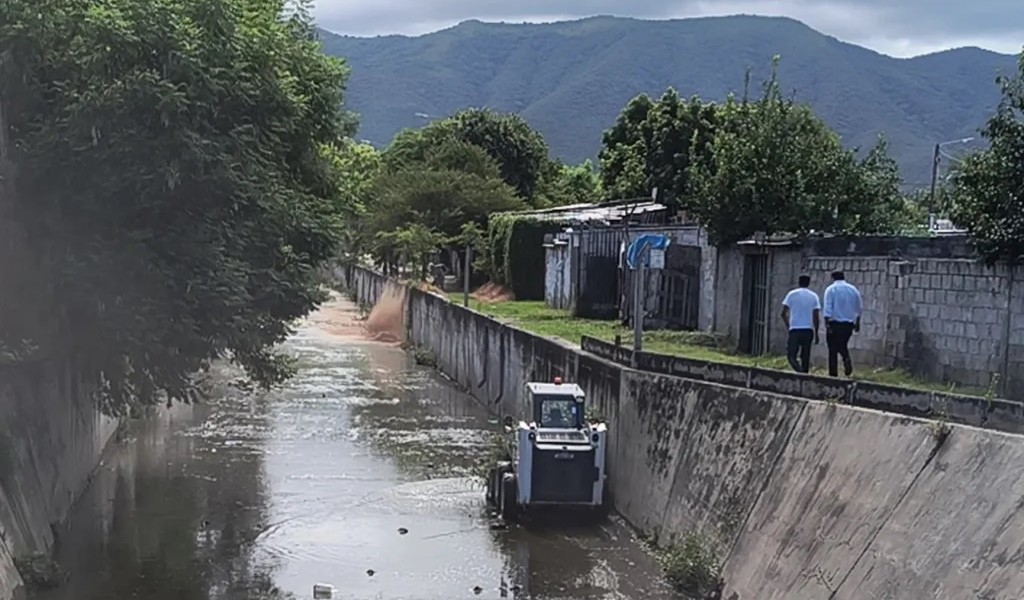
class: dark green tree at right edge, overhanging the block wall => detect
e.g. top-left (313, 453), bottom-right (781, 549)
top-left (947, 54), bottom-right (1024, 265)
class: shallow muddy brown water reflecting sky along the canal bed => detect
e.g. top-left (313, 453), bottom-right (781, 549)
top-left (38, 300), bottom-right (674, 600)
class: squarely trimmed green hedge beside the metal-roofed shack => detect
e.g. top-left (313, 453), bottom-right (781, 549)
top-left (487, 215), bottom-right (562, 300)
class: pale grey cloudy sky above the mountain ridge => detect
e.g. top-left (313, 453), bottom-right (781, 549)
top-left (314, 0), bottom-right (1024, 56)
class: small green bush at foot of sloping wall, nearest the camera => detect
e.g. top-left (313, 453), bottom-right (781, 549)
top-left (658, 533), bottom-right (722, 600)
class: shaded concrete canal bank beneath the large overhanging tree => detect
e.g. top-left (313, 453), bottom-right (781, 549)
top-left (0, 361), bottom-right (117, 600)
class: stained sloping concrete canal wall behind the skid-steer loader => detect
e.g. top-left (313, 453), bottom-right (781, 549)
top-left (339, 268), bottom-right (1024, 600)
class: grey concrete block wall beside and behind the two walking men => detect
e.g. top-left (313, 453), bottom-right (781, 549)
top-left (805, 257), bottom-right (1024, 387)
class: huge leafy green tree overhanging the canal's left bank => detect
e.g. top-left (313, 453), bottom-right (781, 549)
top-left (0, 0), bottom-right (353, 413)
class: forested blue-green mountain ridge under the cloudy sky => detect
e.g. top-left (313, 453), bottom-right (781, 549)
top-left (323, 16), bottom-right (1017, 186)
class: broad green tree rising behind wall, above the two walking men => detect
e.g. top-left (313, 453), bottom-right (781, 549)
top-left (684, 62), bottom-right (921, 244)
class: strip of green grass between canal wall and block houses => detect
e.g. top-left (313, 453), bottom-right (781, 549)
top-left (449, 293), bottom-right (985, 396)
